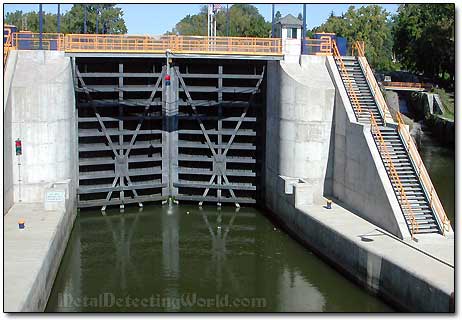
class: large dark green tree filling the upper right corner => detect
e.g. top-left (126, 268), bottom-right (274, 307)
top-left (394, 3), bottom-right (455, 80)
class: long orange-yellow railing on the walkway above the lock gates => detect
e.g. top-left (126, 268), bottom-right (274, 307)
top-left (64, 34), bottom-right (282, 55)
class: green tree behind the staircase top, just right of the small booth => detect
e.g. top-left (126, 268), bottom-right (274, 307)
top-left (312, 5), bottom-right (395, 71)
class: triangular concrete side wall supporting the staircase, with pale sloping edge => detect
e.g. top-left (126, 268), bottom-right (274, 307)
top-left (327, 57), bottom-right (410, 239)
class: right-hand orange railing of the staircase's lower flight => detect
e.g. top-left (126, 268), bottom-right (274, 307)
top-left (397, 112), bottom-right (451, 235)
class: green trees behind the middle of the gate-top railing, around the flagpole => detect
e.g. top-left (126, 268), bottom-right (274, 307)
top-left (167, 4), bottom-right (271, 37)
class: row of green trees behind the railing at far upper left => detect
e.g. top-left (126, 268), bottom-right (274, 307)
top-left (5, 4), bottom-right (127, 34)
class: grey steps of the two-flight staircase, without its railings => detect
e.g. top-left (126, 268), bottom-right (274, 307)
top-left (335, 57), bottom-right (441, 234)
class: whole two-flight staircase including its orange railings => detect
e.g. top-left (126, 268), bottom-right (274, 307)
top-left (334, 45), bottom-right (450, 236)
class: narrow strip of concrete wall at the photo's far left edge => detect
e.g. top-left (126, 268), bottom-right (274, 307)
top-left (3, 51), bottom-right (18, 215)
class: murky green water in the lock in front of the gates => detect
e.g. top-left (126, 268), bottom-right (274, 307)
top-left (46, 205), bottom-right (393, 312)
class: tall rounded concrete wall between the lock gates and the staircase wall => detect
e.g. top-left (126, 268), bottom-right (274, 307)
top-left (265, 56), bottom-right (334, 208)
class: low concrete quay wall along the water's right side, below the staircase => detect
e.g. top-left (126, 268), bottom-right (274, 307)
top-left (271, 178), bottom-right (455, 312)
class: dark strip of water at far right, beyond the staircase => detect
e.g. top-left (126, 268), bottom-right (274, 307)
top-left (419, 133), bottom-right (455, 228)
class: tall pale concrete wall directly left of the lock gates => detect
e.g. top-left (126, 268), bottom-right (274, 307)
top-left (5, 51), bottom-right (77, 203)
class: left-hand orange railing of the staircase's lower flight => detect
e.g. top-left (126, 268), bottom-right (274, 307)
top-left (370, 112), bottom-right (419, 238)
